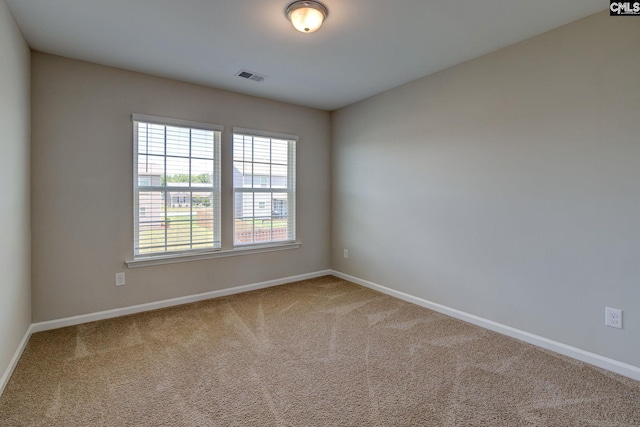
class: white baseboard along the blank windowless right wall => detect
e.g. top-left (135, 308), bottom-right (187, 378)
top-left (331, 270), bottom-right (640, 381)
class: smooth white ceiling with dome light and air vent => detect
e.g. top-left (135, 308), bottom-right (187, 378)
top-left (6, 0), bottom-right (607, 110)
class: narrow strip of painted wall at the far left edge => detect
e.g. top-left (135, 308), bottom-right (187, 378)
top-left (0, 0), bottom-right (31, 382)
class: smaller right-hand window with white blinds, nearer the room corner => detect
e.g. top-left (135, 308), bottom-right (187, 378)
top-left (233, 128), bottom-right (298, 247)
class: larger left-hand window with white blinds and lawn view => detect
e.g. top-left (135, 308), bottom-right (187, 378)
top-left (133, 114), bottom-right (222, 258)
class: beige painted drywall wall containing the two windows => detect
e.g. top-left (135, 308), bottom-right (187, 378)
top-left (32, 52), bottom-right (330, 322)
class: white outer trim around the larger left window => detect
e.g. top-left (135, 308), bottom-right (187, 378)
top-left (132, 113), bottom-right (224, 260)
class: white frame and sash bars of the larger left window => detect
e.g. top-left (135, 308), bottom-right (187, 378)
top-left (127, 114), bottom-right (224, 264)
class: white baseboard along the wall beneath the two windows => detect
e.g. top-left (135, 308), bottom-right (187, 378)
top-left (31, 270), bottom-right (331, 333)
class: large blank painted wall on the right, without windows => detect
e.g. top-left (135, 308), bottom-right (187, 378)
top-left (332, 13), bottom-right (640, 366)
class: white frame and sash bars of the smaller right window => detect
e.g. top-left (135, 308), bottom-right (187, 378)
top-left (231, 127), bottom-right (299, 250)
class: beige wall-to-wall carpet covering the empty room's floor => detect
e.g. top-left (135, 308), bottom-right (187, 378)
top-left (0, 277), bottom-right (640, 427)
